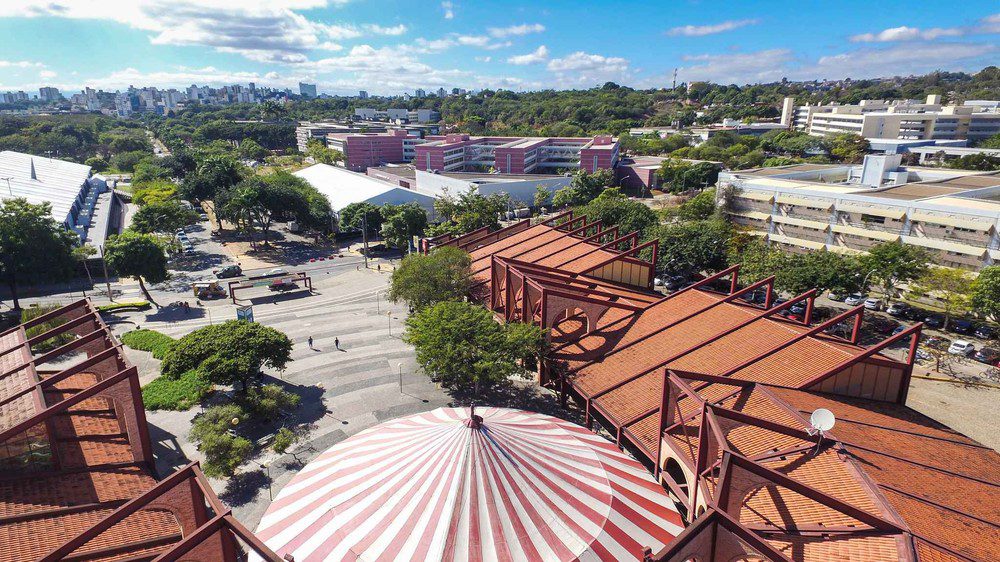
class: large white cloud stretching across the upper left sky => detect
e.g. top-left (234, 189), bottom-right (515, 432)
top-left (0, 0), bottom-right (407, 64)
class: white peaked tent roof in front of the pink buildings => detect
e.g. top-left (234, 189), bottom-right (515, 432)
top-left (295, 164), bottom-right (438, 216)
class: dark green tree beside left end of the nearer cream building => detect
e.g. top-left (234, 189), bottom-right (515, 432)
top-left (656, 220), bottom-right (732, 275)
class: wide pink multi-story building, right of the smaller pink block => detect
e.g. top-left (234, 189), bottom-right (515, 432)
top-left (414, 134), bottom-right (619, 174)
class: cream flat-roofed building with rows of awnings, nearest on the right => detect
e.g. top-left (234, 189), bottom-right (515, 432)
top-left (719, 155), bottom-right (1000, 270)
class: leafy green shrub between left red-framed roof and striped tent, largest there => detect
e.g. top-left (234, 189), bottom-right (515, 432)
top-left (191, 404), bottom-right (253, 477)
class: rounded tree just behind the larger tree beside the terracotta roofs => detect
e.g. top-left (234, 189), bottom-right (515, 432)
top-left (389, 246), bottom-right (472, 309)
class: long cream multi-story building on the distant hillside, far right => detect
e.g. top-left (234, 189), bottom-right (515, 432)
top-left (781, 95), bottom-right (1000, 141)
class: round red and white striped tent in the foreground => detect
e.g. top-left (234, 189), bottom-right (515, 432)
top-left (257, 408), bottom-right (683, 562)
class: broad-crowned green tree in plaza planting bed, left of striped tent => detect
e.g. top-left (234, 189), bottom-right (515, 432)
top-left (161, 320), bottom-right (292, 389)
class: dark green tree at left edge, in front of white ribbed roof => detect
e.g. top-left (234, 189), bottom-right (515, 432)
top-left (0, 198), bottom-right (79, 309)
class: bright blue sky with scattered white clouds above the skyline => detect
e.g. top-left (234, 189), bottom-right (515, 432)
top-left (0, 0), bottom-right (1000, 94)
